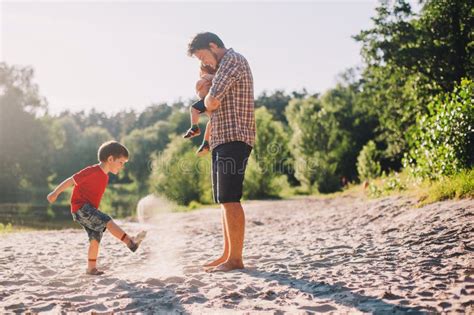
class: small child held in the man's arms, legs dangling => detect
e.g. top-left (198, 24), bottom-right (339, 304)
top-left (183, 65), bottom-right (215, 156)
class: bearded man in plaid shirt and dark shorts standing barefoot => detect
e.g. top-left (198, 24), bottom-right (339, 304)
top-left (188, 33), bottom-right (256, 271)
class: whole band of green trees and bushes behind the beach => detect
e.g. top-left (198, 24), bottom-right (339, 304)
top-left (0, 0), bottom-right (474, 220)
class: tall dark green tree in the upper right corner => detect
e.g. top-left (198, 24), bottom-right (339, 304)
top-left (355, 0), bottom-right (473, 169)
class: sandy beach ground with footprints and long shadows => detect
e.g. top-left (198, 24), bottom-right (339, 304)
top-left (0, 197), bottom-right (474, 314)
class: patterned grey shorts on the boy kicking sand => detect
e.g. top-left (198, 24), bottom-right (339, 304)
top-left (72, 203), bottom-right (112, 242)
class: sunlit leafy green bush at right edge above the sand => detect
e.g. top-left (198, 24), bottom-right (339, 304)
top-left (403, 79), bottom-right (474, 179)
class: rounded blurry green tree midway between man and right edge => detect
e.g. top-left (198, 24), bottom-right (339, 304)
top-left (286, 79), bottom-right (377, 192)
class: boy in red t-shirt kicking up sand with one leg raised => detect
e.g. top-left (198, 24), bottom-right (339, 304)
top-left (47, 141), bottom-right (146, 275)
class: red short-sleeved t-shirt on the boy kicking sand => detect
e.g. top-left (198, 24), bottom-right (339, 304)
top-left (71, 164), bottom-right (109, 213)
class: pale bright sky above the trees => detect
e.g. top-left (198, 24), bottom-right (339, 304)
top-left (0, 0), bottom-right (420, 114)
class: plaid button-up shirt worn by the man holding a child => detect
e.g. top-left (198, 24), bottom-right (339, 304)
top-left (209, 48), bottom-right (256, 150)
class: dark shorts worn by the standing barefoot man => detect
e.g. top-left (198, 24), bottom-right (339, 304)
top-left (212, 141), bottom-right (252, 203)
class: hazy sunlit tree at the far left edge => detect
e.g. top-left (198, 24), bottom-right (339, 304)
top-left (0, 63), bottom-right (49, 202)
